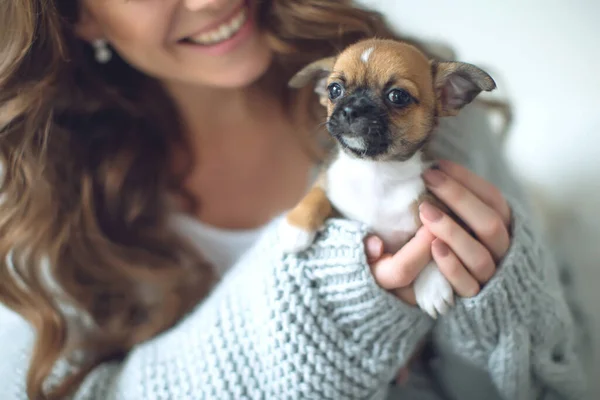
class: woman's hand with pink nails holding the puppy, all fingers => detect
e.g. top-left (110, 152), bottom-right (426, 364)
top-left (366, 161), bottom-right (511, 305)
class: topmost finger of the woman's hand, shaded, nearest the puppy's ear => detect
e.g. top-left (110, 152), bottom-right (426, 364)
top-left (439, 160), bottom-right (511, 226)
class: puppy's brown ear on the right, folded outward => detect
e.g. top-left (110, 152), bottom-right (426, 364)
top-left (431, 61), bottom-right (496, 116)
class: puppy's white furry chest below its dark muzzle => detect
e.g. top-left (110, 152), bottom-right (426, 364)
top-left (327, 156), bottom-right (425, 251)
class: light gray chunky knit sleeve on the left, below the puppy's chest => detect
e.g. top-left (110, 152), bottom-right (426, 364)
top-left (0, 216), bottom-right (432, 400)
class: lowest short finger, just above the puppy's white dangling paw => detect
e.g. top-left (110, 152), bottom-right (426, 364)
top-left (431, 239), bottom-right (480, 297)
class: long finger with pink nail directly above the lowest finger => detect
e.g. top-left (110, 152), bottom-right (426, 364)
top-left (419, 202), bottom-right (496, 283)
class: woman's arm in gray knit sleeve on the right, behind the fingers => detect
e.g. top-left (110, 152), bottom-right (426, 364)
top-left (429, 107), bottom-right (586, 400)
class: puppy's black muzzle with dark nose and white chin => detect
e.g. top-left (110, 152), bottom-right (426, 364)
top-left (327, 93), bottom-right (390, 156)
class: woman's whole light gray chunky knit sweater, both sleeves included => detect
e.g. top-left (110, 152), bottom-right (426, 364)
top-left (0, 106), bottom-right (585, 400)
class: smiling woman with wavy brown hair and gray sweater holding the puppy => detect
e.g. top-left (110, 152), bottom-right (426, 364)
top-left (0, 0), bottom-right (583, 399)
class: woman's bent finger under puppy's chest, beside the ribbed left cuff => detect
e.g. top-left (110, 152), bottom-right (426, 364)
top-left (371, 227), bottom-right (434, 290)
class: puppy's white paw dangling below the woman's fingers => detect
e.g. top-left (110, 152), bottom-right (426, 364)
top-left (414, 262), bottom-right (454, 318)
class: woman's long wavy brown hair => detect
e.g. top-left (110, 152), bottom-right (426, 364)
top-left (0, 0), bottom-right (452, 399)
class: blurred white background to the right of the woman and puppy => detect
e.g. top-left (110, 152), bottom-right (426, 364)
top-left (361, 0), bottom-right (600, 398)
